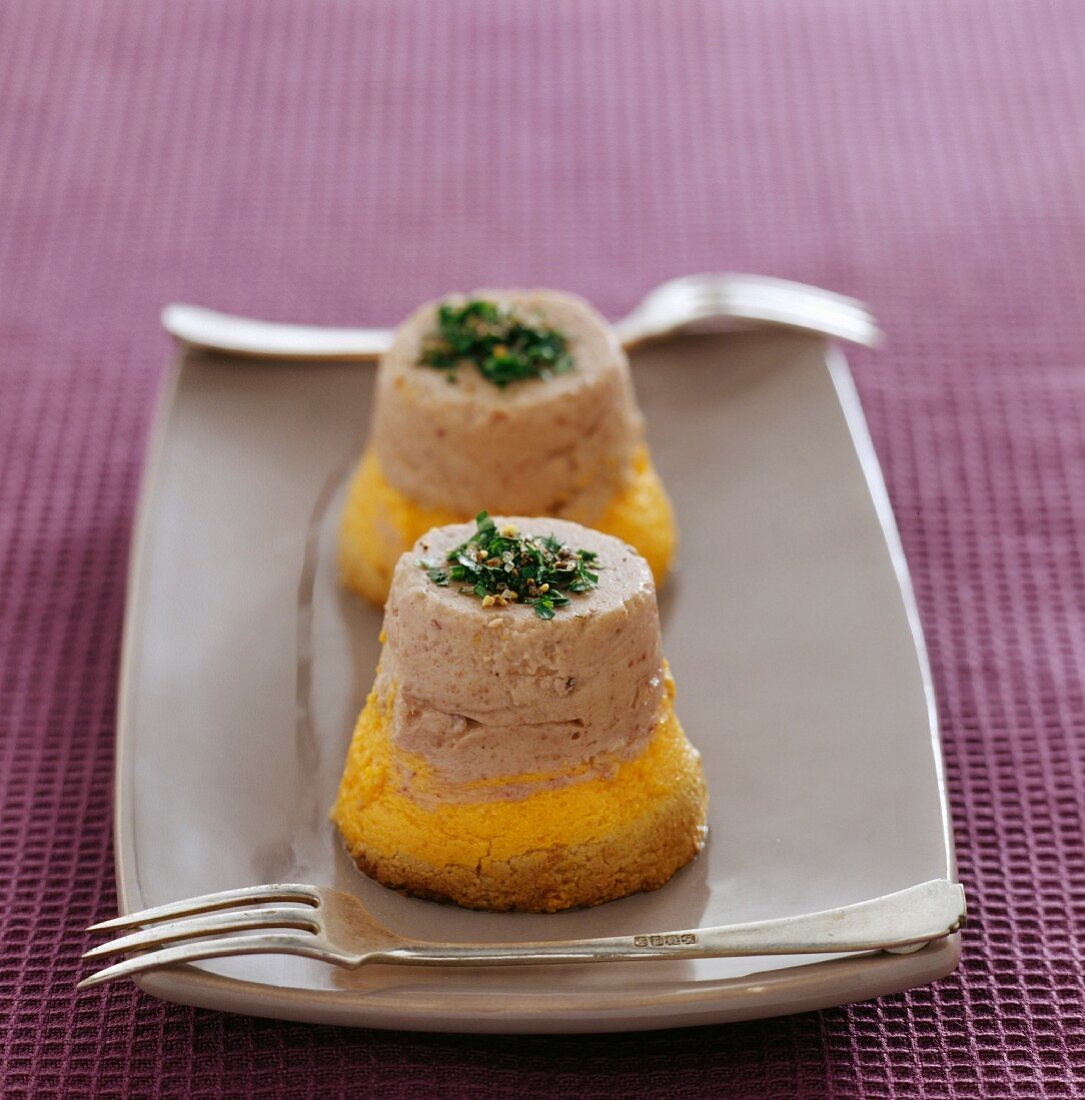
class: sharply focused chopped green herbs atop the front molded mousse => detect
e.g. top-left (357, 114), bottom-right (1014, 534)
top-left (418, 512), bottom-right (599, 619)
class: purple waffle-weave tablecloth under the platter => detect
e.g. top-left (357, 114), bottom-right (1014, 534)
top-left (0, 0), bottom-right (1085, 1098)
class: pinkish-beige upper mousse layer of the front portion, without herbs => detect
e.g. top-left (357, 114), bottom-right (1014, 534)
top-left (377, 517), bottom-right (664, 801)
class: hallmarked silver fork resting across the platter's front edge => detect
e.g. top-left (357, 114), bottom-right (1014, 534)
top-left (78, 879), bottom-right (965, 989)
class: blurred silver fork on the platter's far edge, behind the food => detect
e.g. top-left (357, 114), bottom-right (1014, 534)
top-left (162, 275), bottom-right (881, 361)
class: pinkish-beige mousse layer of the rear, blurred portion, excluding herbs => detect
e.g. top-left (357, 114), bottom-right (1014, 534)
top-left (371, 290), bottom-right (643, 521)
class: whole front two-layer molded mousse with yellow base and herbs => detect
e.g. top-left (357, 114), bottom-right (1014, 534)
top-left (332, 514), bottom-right (706, 912)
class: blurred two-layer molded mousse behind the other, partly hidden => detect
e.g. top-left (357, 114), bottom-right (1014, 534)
top-left (340, 290), bottom-right (676, 603)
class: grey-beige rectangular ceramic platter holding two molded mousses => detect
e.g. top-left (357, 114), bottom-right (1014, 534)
top-left (112, 331), bottom-right (960, 1032)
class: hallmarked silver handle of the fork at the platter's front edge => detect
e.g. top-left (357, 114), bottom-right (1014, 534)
top-left (367, 879), bottom-right (965, 966)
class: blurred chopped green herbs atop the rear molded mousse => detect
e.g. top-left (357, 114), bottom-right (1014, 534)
top-left (418, 298), bottom-right (572, 389)
